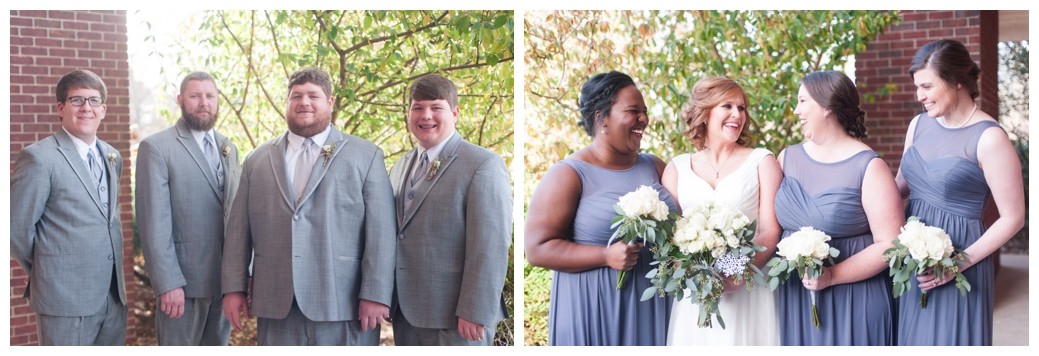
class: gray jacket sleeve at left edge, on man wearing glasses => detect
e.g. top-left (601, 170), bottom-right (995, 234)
top-left (10, 149), bottom-right (49, 274)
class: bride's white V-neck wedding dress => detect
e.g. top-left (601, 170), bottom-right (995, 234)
top-left (667, 148), bottom-right (779, 346)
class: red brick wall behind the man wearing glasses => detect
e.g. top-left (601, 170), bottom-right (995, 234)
top-left (10, 10), bottom-right (135, 345)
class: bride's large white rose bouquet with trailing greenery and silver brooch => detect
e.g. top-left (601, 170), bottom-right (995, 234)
top-left (642, 202), bottom-right (765, 329)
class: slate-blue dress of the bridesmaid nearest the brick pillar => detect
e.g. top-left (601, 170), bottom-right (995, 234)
top-left (898, 114), bottom-right (1000, 346)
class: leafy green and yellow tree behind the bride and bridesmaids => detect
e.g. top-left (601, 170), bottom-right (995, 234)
top-left (524, 10), bottom-right (899, 344)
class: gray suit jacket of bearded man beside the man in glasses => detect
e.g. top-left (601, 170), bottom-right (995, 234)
top-left (134, 118), bottom-right (241, 298)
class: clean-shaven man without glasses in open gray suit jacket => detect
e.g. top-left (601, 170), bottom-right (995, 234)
top-left (390, 75), bottom-right (512, 346)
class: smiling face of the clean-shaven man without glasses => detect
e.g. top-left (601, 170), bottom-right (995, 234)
top-left (407, 99), bottom-right (458, 148)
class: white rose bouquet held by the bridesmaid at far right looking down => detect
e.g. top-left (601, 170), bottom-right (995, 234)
top-left (884, 216), bottom-right (970, 307)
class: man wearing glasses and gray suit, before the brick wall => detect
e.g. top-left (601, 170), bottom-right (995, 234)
top-left (10, 70), bottom-right (127, 346)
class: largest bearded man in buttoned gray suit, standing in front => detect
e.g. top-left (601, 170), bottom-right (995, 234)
top-left (222, 67), bottom-right (397, 346)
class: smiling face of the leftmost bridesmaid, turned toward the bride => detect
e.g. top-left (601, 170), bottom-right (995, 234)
top-left (596, 85), bottom-right (649, 153)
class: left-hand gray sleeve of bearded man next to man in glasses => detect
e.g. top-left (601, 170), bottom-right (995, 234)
top-left (134, 140), bottom-right (187, 294)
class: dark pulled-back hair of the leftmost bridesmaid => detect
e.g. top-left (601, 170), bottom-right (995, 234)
top-left (578, 71), bottom-right (635, 137)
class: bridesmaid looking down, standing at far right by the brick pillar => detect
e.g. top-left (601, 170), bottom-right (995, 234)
top-left (896, 39), bottom-right (1024, 346)
